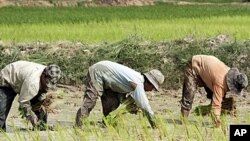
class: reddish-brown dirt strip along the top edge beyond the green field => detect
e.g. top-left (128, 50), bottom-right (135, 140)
top-left (0, 0), bottom-right (250, 7)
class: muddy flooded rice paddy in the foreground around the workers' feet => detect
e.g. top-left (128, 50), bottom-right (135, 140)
top-left (0, 89), bottom-right (250, 141)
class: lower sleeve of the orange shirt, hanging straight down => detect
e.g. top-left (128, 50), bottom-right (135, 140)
top-left (212, 86), bottom-right (225, 116)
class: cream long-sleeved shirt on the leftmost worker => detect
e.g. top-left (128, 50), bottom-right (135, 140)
top-left (0, 61), bottom-right (46, 104)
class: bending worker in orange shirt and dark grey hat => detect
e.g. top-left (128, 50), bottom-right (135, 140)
top-left (180, 55), bottom-right (248, 127)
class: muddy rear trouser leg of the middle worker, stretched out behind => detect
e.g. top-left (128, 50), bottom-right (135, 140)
top-left (76, 74), bottom-right (98, 127)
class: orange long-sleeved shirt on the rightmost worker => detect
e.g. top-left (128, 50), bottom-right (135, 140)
top-left (192, 55), bottom-right (230, 115)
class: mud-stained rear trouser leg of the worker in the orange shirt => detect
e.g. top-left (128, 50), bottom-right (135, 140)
top-left (181, 61), bottom-right (199, 117)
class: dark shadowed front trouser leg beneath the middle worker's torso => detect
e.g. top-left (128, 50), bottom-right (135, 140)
top-left (101, 89), bottom-right (122, 117)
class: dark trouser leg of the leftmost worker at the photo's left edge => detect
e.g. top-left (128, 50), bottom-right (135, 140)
top-left (0, 87), bottom-right (17, 131)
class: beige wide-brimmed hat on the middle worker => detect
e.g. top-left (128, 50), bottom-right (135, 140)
top-left (144, 69), bottom-right (164, 91)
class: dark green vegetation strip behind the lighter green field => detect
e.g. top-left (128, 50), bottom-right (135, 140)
top-left (0, 4), bottom-right (250, 25)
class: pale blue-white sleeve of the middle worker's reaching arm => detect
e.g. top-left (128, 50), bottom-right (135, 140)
top-left (131, 84), bottom-right (154, 115)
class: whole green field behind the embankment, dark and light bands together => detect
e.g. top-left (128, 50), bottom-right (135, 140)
top-left (0, 4), bottom-right (250, 43)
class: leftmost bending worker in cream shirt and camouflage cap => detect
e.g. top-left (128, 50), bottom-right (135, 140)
top-left (0, 61), bottom-right (61, 131)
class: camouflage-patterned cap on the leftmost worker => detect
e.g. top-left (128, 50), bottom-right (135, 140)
top-left (44, 64), bottom-right (62, 89)
